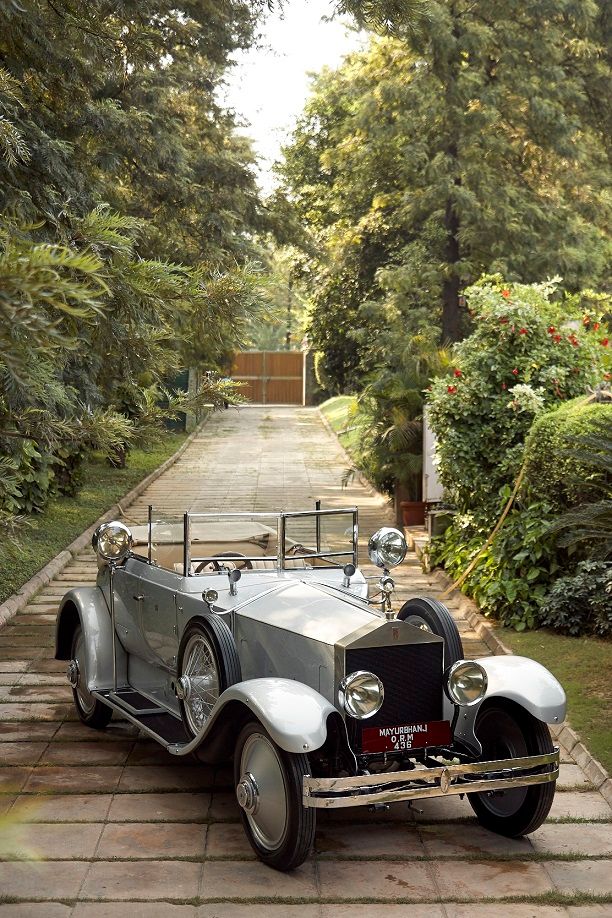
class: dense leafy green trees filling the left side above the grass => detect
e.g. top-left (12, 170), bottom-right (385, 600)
top-left (0, 0), bottom-right (265, 513)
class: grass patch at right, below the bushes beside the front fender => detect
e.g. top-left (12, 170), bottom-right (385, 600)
top-left (497, 628), bottom-right (612, 774)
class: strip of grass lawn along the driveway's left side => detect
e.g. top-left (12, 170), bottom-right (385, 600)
top-left (0, 432), bottom-right (187, 602)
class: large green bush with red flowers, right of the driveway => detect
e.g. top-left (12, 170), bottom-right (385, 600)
top-left (428, 278), bottom-right (608, 521)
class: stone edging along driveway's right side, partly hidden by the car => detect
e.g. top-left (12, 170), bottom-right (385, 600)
top-left (409, 533), bottom-right (612, 806)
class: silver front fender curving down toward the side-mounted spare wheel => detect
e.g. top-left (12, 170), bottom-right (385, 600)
top-left (169, 678), bottom-right (336, 755)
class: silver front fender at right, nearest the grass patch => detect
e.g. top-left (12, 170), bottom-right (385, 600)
top-left (454, 656), bottom-right (567, 755)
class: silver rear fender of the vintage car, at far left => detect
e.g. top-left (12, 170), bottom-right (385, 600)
top-left (55, 587), bottom-right (127, 691)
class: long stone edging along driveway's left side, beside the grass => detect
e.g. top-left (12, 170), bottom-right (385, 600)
top-left (0, 420), bottom-right (206, 629)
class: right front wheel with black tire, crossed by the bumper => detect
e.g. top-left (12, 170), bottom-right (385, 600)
top-left (468, 699), bottom-right (556, 838)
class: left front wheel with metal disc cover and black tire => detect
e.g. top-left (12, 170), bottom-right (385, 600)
top-left (234, 721), bottom-right (316, 870)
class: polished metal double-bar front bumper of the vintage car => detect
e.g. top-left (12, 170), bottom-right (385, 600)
top-left (303, 748), bottom-right (559, 809)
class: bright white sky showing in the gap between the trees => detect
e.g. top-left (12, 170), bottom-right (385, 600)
top-left (225, 0), bottom-right (363, 193)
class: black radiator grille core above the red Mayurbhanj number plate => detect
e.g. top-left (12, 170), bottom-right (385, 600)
top-left (346, 641), bottom-right (443, 751)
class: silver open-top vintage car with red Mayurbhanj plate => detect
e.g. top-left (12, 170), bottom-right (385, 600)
top-left (56, 507), bottom-right (565, 870)
